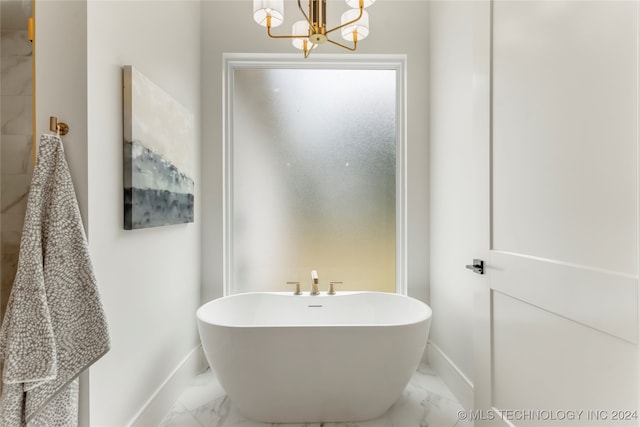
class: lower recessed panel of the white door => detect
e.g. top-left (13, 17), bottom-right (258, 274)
top-left (493, 292), bottom-right (637, 426)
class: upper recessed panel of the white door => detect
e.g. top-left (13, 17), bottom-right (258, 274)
top-left (492, 1), bottom-right (638, 275)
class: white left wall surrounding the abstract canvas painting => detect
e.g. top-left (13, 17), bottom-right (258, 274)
top-left (85, 1), bottom-right (202, 426)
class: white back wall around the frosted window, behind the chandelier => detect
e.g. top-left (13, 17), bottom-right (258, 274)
top-left (202, 0), bottom-right (429, 301)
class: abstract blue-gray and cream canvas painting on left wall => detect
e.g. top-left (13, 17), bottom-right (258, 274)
top-left (123, 65), bottom-right (195, 230)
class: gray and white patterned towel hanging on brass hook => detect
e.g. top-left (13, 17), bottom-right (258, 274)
top-left (0, 135), bottom-right (109, 427)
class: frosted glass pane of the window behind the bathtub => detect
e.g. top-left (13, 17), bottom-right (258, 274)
top-left (227, 68), bottom-right (397, 293)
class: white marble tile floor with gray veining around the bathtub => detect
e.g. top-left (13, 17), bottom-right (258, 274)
top-left (160, 364), bottom-right (473, 427)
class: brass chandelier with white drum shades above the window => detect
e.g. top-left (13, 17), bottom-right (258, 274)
top-left (253, 0), bottom-right (376, 58)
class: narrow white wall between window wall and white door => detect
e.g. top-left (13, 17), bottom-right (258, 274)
top-left (429, 1), bottom-right (488, 406)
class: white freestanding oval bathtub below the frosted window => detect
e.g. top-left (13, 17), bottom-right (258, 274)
top-left (197, 292), bottom-right (431, 423)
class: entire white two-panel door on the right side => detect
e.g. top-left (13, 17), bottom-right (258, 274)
top-left (474, 1), bottom-right (639, 426)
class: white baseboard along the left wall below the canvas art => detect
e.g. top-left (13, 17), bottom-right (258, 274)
top-left (128, 345), bottom-right (208, 427)
